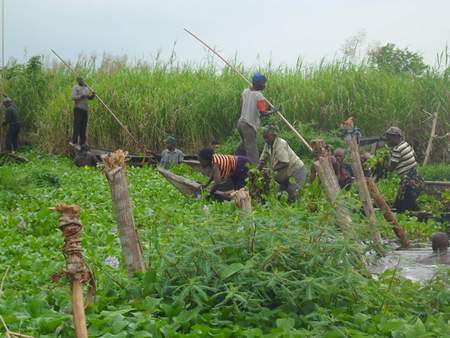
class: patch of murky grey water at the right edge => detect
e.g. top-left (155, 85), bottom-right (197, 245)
top-left (369, 248), bottom-right (450, 282)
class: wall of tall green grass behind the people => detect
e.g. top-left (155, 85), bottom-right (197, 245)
top-left (4, 58), bottom-right (450, 160)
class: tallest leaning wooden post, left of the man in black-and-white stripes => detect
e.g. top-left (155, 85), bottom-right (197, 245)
top-left (341, 117), bottom-right (381, 245)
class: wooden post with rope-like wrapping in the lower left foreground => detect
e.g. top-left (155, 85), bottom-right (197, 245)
top-left (52, 204), bottom-right (95, 338)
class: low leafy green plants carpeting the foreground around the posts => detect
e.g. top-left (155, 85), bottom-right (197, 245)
top-left (0, 153), bottom-right (450, 338)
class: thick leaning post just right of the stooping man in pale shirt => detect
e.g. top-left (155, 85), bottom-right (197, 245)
top-left (311, 139), bottom-right (352, 236)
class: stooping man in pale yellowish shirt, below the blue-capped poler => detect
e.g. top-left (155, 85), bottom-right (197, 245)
top-left (258, 125), bottom-right (306, 203)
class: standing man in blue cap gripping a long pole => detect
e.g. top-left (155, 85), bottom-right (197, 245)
top-left (236, 73), bottom-right (273, 164)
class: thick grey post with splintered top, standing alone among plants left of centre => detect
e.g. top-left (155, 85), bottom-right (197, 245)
top-left (103, 150), bottom-right (147, 277)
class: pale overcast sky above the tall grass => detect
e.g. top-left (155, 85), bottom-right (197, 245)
top-left (4, 0), bottom-right (450, 66)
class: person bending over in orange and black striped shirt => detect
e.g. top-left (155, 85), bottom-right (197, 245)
top-left (198, 148), bottom-right (249, 194)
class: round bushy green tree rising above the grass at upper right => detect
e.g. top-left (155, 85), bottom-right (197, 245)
top-left (369, 43), bottom-right (428, 75)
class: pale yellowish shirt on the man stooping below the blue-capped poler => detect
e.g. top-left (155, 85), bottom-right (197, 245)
top-left (260, 137), bottom-right (305, 176)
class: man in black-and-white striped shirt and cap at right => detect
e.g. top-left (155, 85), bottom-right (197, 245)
top-left (385, 127), bottom-right (423, 212)
